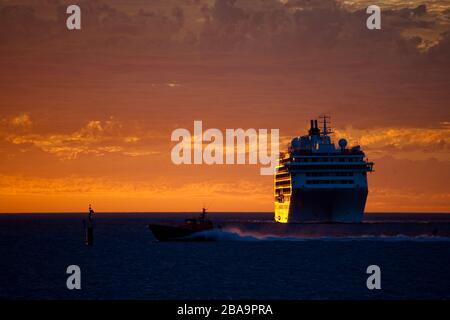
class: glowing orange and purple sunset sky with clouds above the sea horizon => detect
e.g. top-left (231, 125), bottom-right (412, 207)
top-left (0, 0), bottom-right (450, 212)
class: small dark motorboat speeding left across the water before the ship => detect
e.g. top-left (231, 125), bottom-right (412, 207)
top-left (148, 208), bottom-right (214, 241)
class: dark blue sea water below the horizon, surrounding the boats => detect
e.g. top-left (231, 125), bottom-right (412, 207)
top-left (0, 213), bottom-right (450, 299)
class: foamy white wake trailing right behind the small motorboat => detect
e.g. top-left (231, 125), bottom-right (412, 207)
top-left (186, 228), bottom-right (450, 242)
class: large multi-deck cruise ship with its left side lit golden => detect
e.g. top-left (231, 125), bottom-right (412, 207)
top-left (275, 116), bottom-right (374, 223)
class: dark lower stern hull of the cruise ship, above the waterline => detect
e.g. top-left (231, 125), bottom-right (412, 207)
top-left (275, 188), bottom-right (368, 223)
